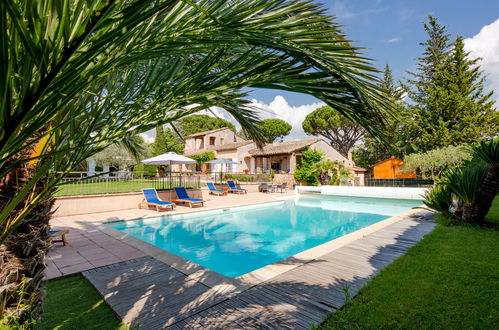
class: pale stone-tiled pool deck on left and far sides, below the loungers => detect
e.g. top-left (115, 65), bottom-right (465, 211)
top-left (45, 191), bottom-right (293, 280)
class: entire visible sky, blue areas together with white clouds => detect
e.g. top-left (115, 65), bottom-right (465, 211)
top-left (143, 0), bottom-right (499, 142)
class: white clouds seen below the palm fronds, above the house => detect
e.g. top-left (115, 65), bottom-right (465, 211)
top-left (140, 95), bottom-right (325, 143)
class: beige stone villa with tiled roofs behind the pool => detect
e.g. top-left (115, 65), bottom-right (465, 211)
top-left (184, 127), bottom-right (366, 185)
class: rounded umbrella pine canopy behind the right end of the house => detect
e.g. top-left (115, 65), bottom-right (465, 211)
top-left (302, 105), bottom-right (365, 156)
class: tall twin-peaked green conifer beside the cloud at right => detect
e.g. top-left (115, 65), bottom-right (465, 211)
top-left (404, 16), bottom-right (498, 152)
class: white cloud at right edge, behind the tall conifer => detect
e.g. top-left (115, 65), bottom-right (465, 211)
top-left (464, 19), bottom-right (499, 102)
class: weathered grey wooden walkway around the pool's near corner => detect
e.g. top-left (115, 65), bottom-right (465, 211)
top-left (83, 215), bottom-right (435, 329)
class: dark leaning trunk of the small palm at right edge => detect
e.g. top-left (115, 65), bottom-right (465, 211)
top-left (470, 165), bottom-right (499, 223)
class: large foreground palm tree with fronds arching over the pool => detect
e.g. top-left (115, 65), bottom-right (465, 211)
top-left (0, 0), bottom-right (391, 321)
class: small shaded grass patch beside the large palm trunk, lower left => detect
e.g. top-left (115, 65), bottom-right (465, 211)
top-left (35, 275), bottom-right (126, 329)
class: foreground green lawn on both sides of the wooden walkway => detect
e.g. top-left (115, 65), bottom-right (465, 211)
top-left (36, 197), bottom-right (499, 329)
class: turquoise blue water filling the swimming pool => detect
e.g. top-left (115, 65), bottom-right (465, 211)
top-left (107, 195), bottom-right (421, 277)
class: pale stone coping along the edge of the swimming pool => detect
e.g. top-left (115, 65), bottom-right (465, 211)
top-left (94, 199), bottom-right (428, 295)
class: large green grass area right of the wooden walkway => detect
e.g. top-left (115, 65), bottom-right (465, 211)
top-left (321, 197), bottom-right (499, 329)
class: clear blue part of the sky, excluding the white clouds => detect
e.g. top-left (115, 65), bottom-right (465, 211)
top-left (246, 0), bottom-right (499, 106)
